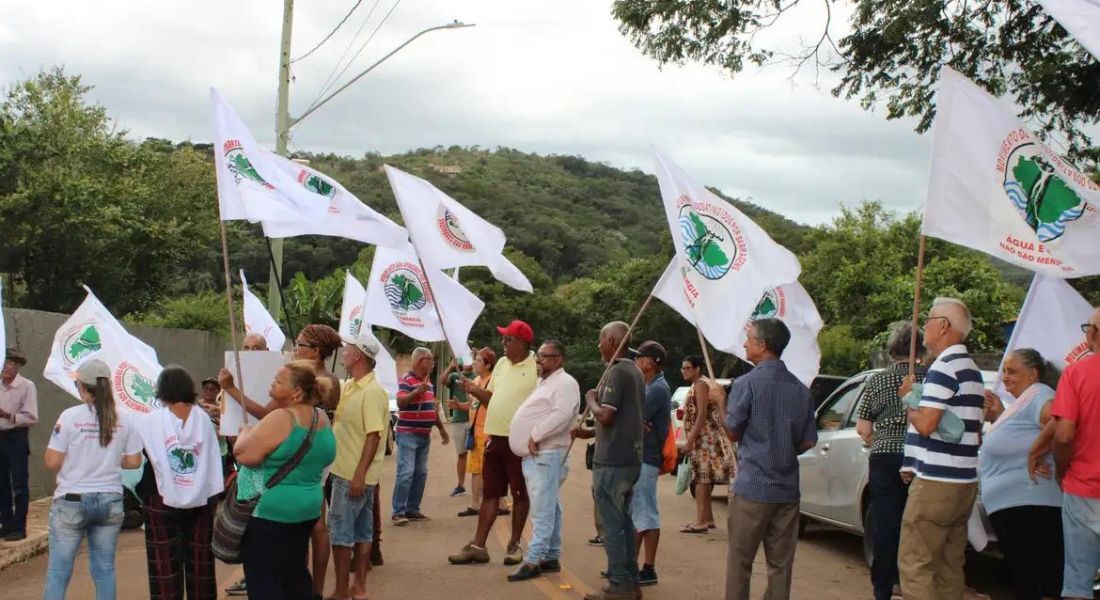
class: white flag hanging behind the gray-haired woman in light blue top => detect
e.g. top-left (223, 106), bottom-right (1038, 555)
top-left (1004, 274), bottom-right (1092, 376)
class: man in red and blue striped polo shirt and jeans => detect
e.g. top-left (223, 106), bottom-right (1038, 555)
top-left (391, 348), bottom-right (450, 525)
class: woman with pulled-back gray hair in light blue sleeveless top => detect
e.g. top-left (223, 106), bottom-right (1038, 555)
top-left (978, 348), bottom-right (1064, 600)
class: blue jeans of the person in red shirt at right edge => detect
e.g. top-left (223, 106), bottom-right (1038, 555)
top-left (1062, 492), bottom-right (1100, 598)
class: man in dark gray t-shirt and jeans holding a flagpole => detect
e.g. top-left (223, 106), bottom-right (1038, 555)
top-left (573, 321), bottom-right (646, 600)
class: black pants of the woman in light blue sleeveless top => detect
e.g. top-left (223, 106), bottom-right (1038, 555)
top-left (989, 506), bottom-right (1065, 600)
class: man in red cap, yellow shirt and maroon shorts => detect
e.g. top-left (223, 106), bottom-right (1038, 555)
top-left (448, 320), bottom-right (539, 571)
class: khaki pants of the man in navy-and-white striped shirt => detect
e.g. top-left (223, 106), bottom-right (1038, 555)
top-left (898, 478), bottom-right (978, 600)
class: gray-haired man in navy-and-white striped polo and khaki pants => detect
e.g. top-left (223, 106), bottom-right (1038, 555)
top-left (898, 298), bottom-right (985, 600)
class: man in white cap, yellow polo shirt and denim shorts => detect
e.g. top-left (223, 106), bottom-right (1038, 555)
top-left (328, 337), bottom-right (389, 598)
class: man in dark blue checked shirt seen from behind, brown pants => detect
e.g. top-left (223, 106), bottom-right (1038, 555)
top-left (726, 318), bottom-right (817, 600)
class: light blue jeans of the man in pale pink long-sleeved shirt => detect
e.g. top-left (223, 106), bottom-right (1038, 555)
top-left (524, 448), bottom-right (569, 565)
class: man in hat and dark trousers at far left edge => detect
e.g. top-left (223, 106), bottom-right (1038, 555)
top-left (0, 348), bottom-right (39, 542)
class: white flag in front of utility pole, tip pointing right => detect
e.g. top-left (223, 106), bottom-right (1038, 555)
top-left (263, 151), bottom-right (408, 246)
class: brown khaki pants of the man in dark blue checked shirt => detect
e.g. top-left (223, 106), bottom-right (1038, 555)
top-left (726, 495), bottom-right (799, 600)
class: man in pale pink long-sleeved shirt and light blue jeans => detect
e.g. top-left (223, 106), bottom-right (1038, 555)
top-left (508, 340), bottom-right (581, 581)
